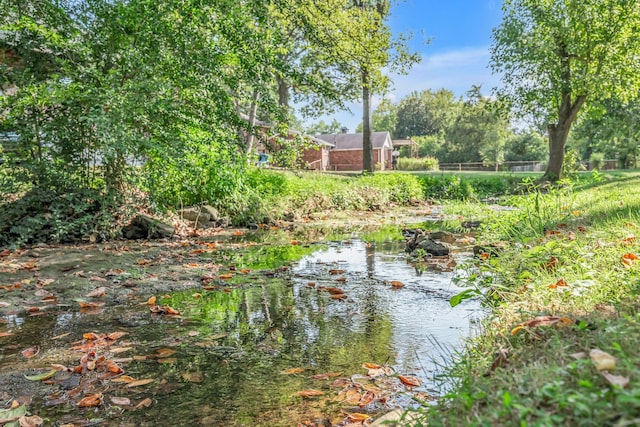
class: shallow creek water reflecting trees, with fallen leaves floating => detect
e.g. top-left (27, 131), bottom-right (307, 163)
top-left (0, 238), bottom-right (482, 426)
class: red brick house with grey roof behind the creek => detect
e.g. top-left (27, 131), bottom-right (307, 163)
top-left (315, 132), bottom-right (393, 171)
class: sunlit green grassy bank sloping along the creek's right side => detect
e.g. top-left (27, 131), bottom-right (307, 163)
top-left (420, 171), bottom-right (640, 426)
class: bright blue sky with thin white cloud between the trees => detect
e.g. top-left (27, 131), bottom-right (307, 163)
top-left (307, 0), bottom-right (502, 132)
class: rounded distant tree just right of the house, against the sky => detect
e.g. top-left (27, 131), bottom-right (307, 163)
top-left (394, 89), bottom-right (461, 138)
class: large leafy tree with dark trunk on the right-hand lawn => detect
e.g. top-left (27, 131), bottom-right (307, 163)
top-left (491, 0), bottom-right (640, 180)
